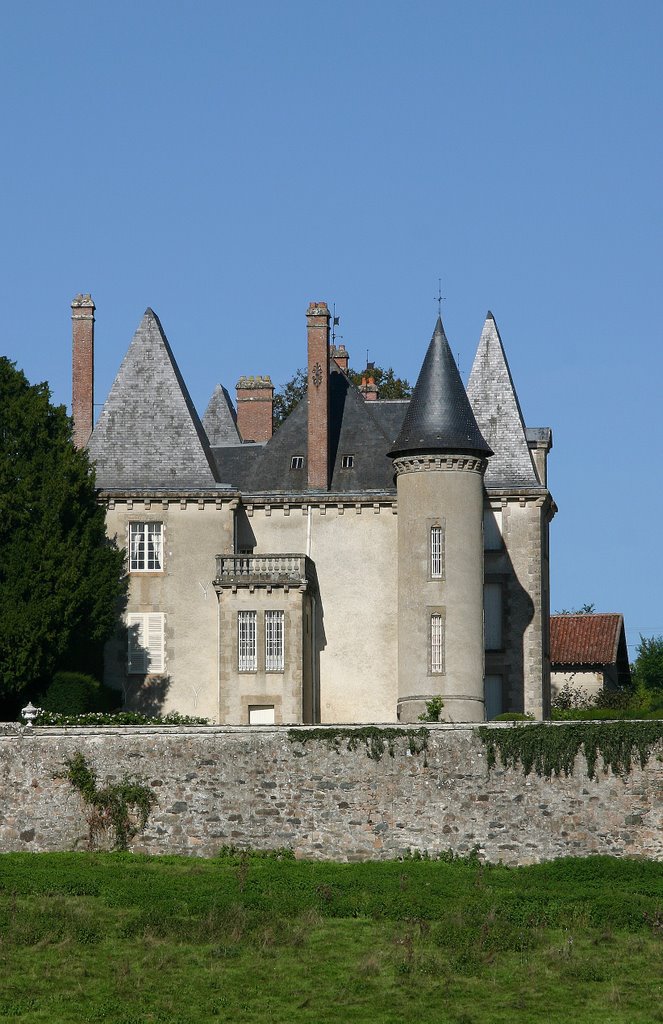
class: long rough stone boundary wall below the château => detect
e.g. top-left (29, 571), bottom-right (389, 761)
top-left (0, 725), bottom-right (663, 864)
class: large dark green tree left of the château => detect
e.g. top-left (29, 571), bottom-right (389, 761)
top-left (0, 357), bottom-right (126, 702)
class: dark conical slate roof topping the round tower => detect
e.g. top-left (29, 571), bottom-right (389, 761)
top-left (389, 316), bottom-right (492, 457)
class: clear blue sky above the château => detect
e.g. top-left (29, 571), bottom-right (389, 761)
top-left (0, 0), bottom-right (663, 655)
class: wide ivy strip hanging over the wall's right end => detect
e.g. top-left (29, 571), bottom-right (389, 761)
top-left (478, 721), bottom-right (663, 778)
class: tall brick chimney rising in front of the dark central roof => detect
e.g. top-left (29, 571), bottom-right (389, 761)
top-left (306, 302), bottom-right (330, 490)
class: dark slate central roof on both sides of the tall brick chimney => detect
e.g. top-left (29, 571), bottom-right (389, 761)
top-left (213, 364), bottom-right (396, 494)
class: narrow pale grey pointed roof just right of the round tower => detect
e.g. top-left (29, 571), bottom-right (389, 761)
top-left (467, 312), bottom-right (539, 487)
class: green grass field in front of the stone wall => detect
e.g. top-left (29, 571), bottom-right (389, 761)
top-left (0, 853), bottom-right (663, 1024)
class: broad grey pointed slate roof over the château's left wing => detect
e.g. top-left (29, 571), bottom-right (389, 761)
top-left (88, 309), bottom-right (215, 490)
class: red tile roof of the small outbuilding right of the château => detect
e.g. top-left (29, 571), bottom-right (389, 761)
top-left (550, 614), bottom-right (624, 665)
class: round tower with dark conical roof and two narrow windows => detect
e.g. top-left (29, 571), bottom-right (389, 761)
top-left (389, 317), bottom-right (493, 722)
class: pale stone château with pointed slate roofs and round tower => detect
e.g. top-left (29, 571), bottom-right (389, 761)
top-left (75, 303), bottom-right (554, 725)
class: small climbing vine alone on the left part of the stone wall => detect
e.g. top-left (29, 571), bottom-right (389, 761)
top-left (65, 751), bottom-right (157, 850)
